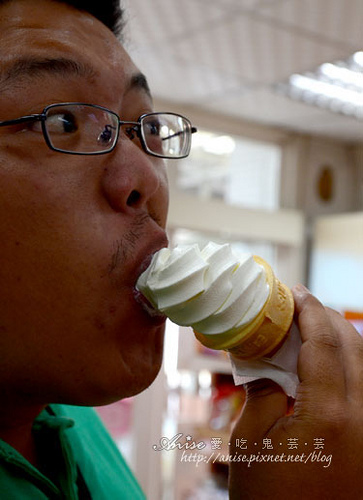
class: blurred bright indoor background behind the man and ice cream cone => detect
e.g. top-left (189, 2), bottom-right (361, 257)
top-left (99, 0), bottom-right (363, 500)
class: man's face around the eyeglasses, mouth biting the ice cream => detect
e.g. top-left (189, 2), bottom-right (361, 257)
top-left (0, 0), bottom-right (168, 404)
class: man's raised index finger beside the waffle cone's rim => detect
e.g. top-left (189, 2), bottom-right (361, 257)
top-left (293, 285), bottom-right (345, 399)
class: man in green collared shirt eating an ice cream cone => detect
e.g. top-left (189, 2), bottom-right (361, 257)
top-left (0, 0), bottom-right (362, 499)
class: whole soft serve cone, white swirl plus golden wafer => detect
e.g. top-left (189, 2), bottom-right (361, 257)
top-left (137, 242), bottom-right (293, 359)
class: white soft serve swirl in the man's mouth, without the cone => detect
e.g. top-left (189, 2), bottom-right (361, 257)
top-left (137, 242), bottom-right (269, 335)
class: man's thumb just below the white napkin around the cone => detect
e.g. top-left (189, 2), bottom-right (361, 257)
top-left (231, 379), bottom-right (288, 445)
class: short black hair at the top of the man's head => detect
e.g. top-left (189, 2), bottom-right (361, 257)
top-left (0, 0), bottom-right (124, 37)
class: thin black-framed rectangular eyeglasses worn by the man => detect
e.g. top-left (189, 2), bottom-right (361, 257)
top-left (0, 102), bottom-right (197, 158)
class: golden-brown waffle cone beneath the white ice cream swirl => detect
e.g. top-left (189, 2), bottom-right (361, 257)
top-left (194, 256), bottom-right (294, 360)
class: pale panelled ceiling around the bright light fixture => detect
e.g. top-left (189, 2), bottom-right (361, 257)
top-left (122, 0), bottom-right (363, 142)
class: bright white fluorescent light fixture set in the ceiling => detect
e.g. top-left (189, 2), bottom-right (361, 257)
top-left (276, 52), bottom-right (363, 120)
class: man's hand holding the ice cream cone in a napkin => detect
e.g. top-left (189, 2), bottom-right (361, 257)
top-left (230, 285), bottom-right (363, 500)
